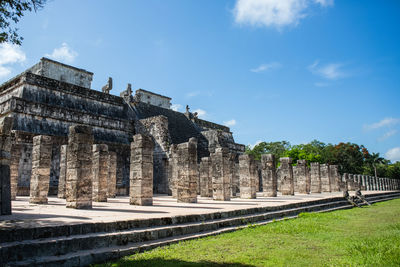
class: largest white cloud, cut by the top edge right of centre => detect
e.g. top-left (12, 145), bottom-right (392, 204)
top-left (233, 0), bottom-right (333, 29)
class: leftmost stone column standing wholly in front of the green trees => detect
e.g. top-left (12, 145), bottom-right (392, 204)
top-left (261, 154), bottom-right (278, 197)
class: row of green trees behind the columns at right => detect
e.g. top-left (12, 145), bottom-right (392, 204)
top-left (246, 140), bottom-right (400, 179)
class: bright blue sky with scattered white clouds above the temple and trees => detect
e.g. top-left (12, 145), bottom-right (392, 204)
top-left (0, 0), bottom-right (400, 161)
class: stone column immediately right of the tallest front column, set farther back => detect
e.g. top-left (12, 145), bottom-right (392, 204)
top-left (92, 144), bottom-right (109, 202)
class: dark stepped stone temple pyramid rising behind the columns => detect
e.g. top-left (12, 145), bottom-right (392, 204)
top-left (0, 58), bottom-right (245, 199)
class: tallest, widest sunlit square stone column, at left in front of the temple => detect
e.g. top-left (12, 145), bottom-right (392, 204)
top-left (65, 125), bottom-right (93, 209)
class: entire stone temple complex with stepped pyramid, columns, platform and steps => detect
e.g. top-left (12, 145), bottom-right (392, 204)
top-left (0, 58), bottom-right (400, 266)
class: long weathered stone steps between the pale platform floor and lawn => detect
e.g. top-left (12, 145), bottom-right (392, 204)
top-left (0, 193), bottom-right (400, 266)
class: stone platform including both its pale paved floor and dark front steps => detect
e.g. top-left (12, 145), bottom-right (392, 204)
top-left (0, 191), bottom-right (400, 267)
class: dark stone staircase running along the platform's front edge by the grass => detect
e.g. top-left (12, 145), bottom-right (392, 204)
top-left (0, 192), bottom-right (400, 266)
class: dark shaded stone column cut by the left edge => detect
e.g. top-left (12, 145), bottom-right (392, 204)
top-left (0, 117), bottom-right (13, 215)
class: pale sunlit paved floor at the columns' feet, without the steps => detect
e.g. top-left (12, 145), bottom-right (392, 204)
top-left (0, 191), bottom-right (391, 230)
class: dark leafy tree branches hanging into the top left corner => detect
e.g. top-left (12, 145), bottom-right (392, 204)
top-left (0, 0), bottom-right (46, 45)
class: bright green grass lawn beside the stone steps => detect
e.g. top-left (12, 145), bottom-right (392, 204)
top-left (99, 199), bottom-right (400, 267)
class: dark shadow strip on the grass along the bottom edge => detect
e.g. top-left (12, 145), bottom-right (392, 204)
top-left (106, 258), bottom-right (254, 267)
